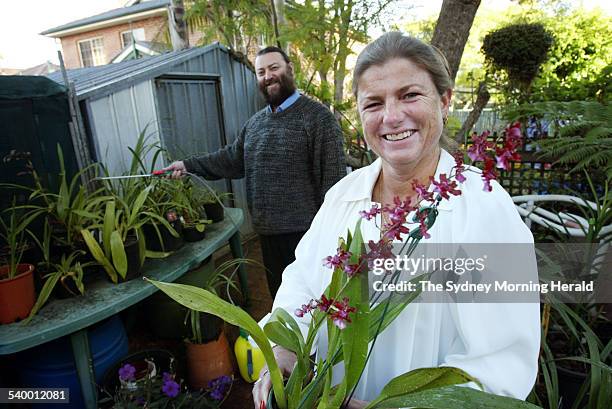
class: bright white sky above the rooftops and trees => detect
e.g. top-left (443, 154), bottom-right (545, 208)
top-left (0, 0), bottom-right (612, 69)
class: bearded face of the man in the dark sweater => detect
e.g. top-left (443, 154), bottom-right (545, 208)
top-left (255, 52), bottom-right (295, 107)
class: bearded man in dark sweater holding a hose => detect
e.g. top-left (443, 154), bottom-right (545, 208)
top-left (166, 47), bottom-right (346, 298)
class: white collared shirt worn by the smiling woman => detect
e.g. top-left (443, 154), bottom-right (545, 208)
top-left (260, 150), bottom-right (540, 401)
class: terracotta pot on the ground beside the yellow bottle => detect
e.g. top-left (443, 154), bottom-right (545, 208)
top-left (185, 332), bottom-right (234, 389)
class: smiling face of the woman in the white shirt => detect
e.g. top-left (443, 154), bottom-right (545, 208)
top-left (357, 58), bottom-right (451, 169)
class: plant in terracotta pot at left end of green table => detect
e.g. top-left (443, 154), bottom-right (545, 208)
top-left (0, 198), bottom-right (35, 324)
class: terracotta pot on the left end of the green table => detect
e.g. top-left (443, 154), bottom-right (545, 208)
top-left (0, 264), bottom-right (36, 324)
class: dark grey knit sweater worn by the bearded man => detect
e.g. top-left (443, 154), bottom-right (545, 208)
top-left (184, 96), bottom-right (346, 234)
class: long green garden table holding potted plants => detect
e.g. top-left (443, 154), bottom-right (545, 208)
top-left (0, 208), bottom-right (248, 409)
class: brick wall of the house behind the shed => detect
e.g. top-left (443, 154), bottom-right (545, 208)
top-left (61, 15), bottom-right (167, 69)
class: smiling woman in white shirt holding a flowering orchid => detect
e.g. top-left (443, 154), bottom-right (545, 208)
top-left (253, 32), bottom-right (540, 408)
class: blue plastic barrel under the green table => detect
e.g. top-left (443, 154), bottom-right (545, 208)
top-left (15, 315), bottom-right (128, 409)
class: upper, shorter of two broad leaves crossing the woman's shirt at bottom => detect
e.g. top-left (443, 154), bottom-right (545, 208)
top-left (368, 367), bottom-right (480, 407)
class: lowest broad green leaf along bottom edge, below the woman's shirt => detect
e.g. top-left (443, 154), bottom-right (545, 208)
top-left (367, 386), bottom-right (539, 409)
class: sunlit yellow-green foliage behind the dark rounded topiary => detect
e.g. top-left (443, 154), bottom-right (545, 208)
top-left (402, 1), bottom-right (612, 106)
